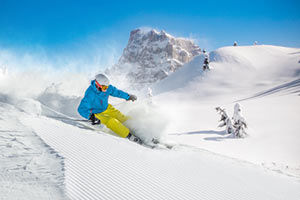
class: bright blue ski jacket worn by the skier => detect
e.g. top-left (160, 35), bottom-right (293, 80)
top-left (78, 80), bottom-right (129, 119)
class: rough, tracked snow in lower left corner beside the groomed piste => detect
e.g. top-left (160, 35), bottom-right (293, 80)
top-left (0, 102), bottom-right (67, 200)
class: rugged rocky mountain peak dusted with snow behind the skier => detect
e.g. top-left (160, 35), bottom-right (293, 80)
top-left (107, 28), bottom-right (201, 88)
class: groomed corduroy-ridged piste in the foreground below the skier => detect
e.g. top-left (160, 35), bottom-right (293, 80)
top-left (20, 115), bottom-right (300, 200)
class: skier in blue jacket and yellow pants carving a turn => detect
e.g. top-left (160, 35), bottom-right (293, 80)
top-left (78, 74), bottom-right (142, 144)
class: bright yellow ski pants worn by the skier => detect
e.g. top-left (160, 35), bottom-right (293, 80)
top-left (95, 104), bottom-right (129, 138)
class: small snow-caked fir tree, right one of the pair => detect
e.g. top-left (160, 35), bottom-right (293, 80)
top-left (232, 103), bottom-right (247, 137)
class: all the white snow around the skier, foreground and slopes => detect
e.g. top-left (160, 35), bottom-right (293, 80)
top-left (0, 45), bottom-right (300, 200)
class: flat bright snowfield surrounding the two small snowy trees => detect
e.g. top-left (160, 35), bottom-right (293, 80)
top-left (155, 94), bottom-right (300, 177)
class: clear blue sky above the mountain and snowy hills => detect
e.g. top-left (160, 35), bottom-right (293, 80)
top-left (0, 0), bottom-right (300, 59)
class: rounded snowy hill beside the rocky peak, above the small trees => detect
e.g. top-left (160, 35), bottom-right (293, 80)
top-left (153, 45), bottom-right (300, 100)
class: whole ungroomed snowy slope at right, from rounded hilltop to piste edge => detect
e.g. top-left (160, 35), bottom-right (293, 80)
top-left (153, 45), bottom-right (300, 177)
